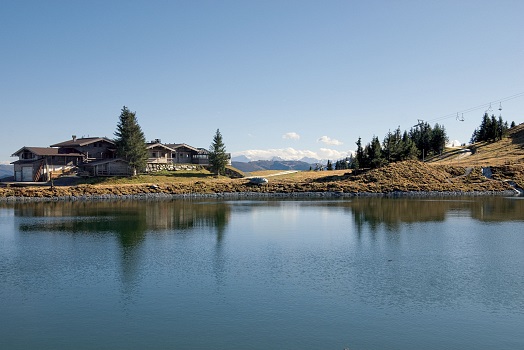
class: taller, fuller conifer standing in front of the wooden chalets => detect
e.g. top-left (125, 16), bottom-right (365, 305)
top-left (115, 106), bottom-right (147, 175)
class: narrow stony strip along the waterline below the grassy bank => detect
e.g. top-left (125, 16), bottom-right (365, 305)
top-left (0, 190), bottom-right (518, 203)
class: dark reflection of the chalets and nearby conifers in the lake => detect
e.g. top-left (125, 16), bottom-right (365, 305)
top-left (14, 200), bottom-right (230, 247)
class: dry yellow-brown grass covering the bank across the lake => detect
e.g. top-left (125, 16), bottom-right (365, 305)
top-left (0, 161), bottom-right (524, 197)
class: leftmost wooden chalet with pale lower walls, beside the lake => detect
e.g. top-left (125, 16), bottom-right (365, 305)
top-left (11, 147), bottom-right (84, 182)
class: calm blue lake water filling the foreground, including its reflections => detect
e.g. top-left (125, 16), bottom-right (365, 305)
top-left (0, 198), bottom-right (524, 350)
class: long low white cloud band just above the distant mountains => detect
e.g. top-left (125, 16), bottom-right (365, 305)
top-left (231, 147), bottom-right (353, 160)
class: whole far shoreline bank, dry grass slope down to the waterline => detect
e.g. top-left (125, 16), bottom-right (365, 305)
top-left (0, 161), bottom-right (524, 202)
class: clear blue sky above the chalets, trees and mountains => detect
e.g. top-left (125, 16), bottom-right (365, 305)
top-left (0, 0), bottom-right (524, 161)
